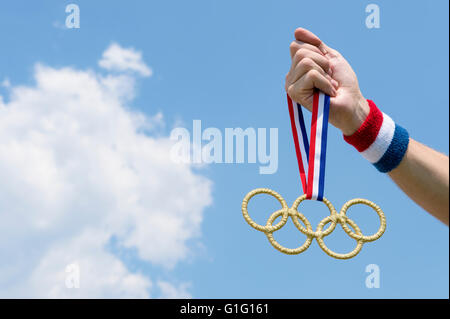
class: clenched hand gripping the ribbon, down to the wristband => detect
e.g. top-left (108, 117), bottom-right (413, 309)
top-left (286, 28), bottom-right (369, 135)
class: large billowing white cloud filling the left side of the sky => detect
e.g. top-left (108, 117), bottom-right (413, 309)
top-left (0, 46), bottom-right (211, 297)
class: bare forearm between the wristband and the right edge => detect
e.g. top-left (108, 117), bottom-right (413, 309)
top-left (388, 139), bottom-right (449, 225)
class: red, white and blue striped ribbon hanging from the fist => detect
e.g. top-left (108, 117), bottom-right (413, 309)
top-left (287, 91), bottom-right (330, 201)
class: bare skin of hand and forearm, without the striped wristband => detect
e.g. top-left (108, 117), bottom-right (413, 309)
top-left (286, 28), bottom-right (449, 226)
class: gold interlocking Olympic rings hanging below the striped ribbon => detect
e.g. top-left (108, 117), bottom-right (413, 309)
top-left (242, 188), bottom-right (386, 259)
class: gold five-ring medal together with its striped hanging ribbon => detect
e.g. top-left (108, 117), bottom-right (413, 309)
top-left (242, 91), bottom-right (386, 259)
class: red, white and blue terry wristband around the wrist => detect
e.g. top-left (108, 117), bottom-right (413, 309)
top-left (344, 100), bottom-right (409, 173)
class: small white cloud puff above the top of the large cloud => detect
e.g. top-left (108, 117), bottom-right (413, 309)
top-left (98, 43), bottom-right (152, 76)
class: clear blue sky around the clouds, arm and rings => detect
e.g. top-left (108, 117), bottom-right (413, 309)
top-left (0, 0), bottom-right (449, 298)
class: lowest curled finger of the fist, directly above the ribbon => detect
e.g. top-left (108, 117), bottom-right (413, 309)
top-left (287, 69), bottom-right (336, 103)
